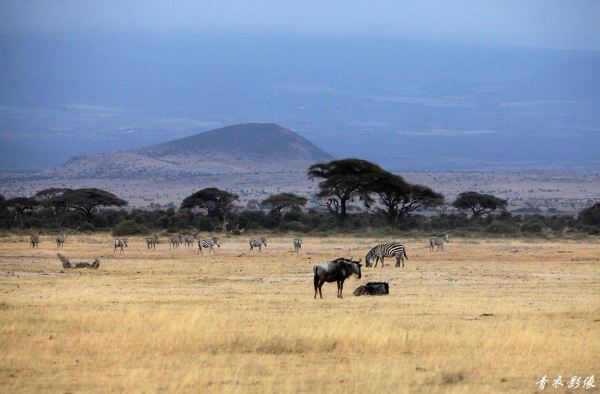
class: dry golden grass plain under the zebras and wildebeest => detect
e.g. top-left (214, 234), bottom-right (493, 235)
top-left (0, 235), bottom-right (600, 393)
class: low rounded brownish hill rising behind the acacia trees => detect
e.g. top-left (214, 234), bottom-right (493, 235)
top-left (44, 123), bottom-right (332, 179)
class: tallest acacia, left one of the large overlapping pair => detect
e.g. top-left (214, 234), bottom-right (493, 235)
top-left (307, 159), bottom-right (388, 220)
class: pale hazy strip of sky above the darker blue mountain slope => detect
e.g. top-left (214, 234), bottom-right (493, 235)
top-left (0, 0), bottom-right (600, 50)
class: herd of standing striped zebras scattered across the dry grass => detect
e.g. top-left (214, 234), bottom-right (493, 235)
top-left (29, 234), bottom-right (450, 268)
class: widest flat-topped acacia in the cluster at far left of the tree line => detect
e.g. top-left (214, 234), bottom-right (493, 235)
top-left (50, 188), bottom-right (127, 221)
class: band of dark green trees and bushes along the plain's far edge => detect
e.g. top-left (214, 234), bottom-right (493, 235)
top-left (0, 159), bottom-right (600, 235)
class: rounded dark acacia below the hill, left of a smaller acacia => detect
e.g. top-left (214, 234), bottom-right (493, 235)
top-left (181, 187), bottom-right (239, 232)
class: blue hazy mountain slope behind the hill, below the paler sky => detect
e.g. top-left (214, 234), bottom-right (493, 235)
top-left (0, 33), bottom-right (600, 172)
